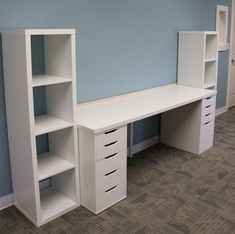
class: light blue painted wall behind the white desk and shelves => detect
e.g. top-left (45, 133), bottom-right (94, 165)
top-left (0, 0), bottom-right (231, 197)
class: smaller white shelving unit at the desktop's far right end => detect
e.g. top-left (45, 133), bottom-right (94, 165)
top-left (178, 31), bottom-right (218, 90)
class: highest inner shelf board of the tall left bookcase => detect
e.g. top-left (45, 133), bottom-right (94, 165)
top-left (32, 75), bottom-right (72, 87)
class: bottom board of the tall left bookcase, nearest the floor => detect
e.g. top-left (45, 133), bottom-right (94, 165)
top-left (40, 187), bottom-right (77, 223)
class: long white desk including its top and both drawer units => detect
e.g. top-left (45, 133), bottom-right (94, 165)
top-left (76, 84), bottom-right (216, 214)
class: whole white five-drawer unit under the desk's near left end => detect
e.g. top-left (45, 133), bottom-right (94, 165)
top-left (79, 126), bottom-right (127, 214)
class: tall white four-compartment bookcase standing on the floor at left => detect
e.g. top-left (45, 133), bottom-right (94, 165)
top-left (2, 29), bottom-right (80, 226)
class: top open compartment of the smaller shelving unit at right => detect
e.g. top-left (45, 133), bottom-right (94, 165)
top-left (205, 34), bottom-right (218, 61)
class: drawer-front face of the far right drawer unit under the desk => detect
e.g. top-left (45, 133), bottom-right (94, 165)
top-left (199, 96), bottom-right (216, 153)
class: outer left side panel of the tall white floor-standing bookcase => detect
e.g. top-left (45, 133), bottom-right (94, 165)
top-left (3, 33), bottom-right (40, 223)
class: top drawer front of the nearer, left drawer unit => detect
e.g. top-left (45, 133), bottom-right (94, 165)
top-left (96, 126), bottom-right (127, 150)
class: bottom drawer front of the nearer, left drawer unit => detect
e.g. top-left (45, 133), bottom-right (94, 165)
top-left (96, 167), bottom-right (126, 213)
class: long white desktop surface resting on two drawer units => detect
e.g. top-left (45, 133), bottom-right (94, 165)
top-left (76, 84), bottom-right (216, 134)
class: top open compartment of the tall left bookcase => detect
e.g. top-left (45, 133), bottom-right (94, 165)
top-left (31, 34), bottom-right (73, 79)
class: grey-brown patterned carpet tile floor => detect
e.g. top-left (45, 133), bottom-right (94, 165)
top-left (0, 109), bottom-right (235, 234)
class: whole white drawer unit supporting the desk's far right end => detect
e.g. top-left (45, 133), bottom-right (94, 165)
top-left (161, 93), bottom-right (216, 154)
